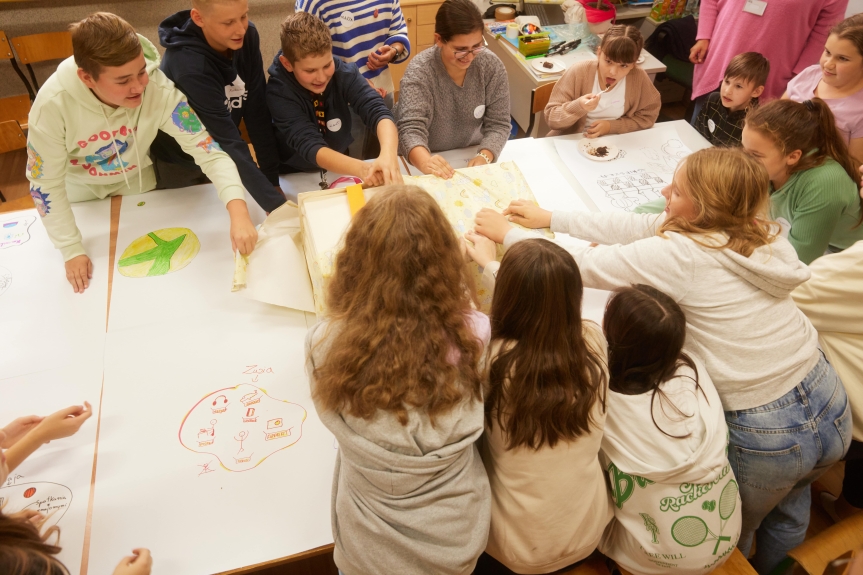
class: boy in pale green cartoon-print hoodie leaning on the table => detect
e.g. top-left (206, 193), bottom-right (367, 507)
top-left (27, 12), bottom-right (257, 293)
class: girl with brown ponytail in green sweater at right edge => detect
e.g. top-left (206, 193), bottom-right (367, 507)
top-left (742, 98), bottom-right (863, 264)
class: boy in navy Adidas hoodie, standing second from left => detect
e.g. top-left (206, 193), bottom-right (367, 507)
top-left (159, 0), bottom-right (285, 212)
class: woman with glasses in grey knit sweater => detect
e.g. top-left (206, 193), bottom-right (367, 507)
top-left (395, 0), bottom-right (511, 178)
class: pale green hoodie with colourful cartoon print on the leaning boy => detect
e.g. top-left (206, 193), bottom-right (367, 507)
top-left (26, 34), bottom-right (245, 261)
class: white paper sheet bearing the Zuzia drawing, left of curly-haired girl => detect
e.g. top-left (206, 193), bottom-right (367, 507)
top-left (90, 310), bottom-right (337, 574)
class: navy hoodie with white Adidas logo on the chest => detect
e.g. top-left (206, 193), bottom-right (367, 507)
top-left (159, 10), bottom-right (286, 212)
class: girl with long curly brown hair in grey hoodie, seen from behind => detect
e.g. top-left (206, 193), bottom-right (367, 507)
top-left (306, 186), bottom-right (490, 575)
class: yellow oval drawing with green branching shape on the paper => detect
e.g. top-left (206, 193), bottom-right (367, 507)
top-left (117, 228), bottom-right (201, 278)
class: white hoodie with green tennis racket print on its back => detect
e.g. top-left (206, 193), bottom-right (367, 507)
top-left (599, 360), bottom-right (742, 575)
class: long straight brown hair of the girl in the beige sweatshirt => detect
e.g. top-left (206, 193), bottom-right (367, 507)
top-left (485, 239), bottom-right (608, 449)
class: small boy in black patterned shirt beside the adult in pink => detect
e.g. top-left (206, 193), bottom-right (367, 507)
top-left (695, 52), bottom-right (770, 147)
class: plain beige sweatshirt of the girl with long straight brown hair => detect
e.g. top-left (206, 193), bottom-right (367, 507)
top-left (480, 321), bottom-right (614, 573)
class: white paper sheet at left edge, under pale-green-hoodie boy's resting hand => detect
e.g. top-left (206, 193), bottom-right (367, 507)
top-left (0, 200), bottom-right (111, 379)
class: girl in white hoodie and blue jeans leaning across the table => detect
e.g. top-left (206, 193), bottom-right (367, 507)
top-left (477, 148), bottom-right (851, 573)
